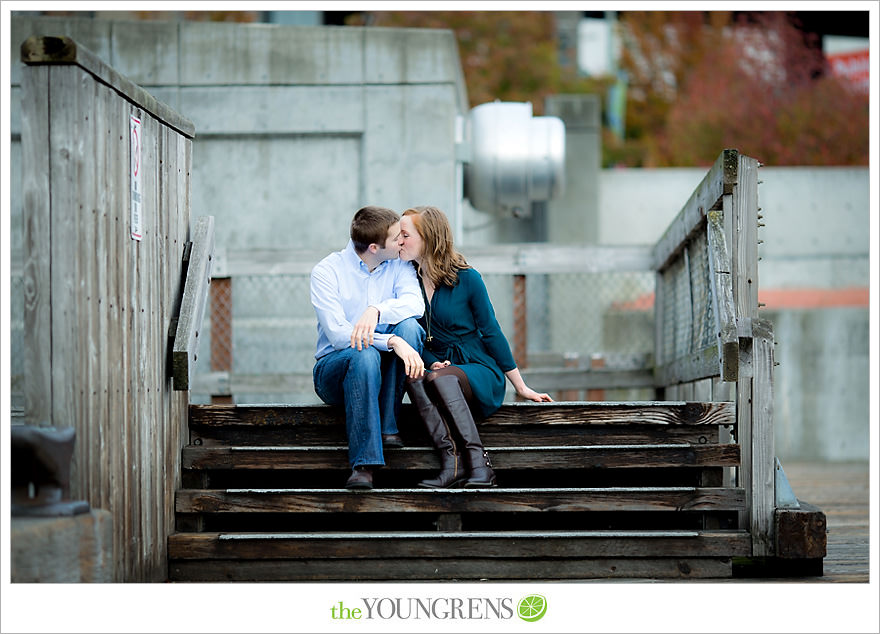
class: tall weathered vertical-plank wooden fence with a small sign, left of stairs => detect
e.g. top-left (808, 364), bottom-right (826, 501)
top-left (21, 37), bottom-right (194, 581)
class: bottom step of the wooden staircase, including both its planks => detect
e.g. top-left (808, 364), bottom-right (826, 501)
top-left (168, 530), bottom-right (750, 581)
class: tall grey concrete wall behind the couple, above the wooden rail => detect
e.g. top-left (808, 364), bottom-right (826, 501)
top-left (8, 16), bottom-right (467, 251)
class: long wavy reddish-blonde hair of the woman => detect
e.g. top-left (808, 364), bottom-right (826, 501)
top-left (402, 205), bottom-right (470, 286)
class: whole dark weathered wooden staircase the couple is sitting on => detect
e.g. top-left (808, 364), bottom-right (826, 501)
top-left (168, 402), bottom-right (751, 582)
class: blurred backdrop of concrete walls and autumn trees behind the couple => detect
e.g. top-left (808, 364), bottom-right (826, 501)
top-left (8, 11), bottom-right (870, 461)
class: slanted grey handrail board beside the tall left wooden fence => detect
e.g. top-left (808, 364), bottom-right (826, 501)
top-left (172, 216), bottom-right (214, 390)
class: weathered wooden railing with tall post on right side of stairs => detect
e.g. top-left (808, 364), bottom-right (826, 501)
top-left (654, 150), bottom-right (775, 557)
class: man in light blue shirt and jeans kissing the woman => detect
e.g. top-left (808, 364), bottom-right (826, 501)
top-left (311, 206), bottom-right (425, 489)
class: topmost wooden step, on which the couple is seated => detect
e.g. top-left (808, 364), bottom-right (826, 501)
top-left (189, 401), bottom-right (735, 447)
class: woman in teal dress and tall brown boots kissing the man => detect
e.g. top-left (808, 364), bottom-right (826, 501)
top-left (398, 207), bottom-right (553, 488)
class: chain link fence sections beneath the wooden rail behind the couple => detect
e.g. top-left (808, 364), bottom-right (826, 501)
top-left (191, 271), bottom-right (654, 404)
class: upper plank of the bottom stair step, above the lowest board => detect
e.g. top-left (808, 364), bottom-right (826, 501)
top-left (168, 530), bottom-right (750, 560)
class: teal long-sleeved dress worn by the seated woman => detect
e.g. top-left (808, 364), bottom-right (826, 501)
top-left (419, 269), bottom-right (516, 417)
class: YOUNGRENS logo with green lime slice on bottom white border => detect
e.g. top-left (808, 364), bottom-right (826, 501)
top-left (330, 594), bottom-right (547, 622)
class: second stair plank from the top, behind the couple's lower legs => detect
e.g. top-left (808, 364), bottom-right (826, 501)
top-left (182, 444), bottom-right (739, 470)
